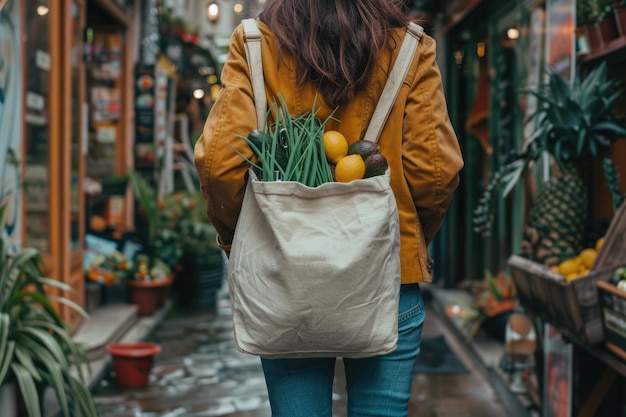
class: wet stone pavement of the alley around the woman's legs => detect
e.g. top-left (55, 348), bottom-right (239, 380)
top-left (94, 286), bottom-right (507, 417)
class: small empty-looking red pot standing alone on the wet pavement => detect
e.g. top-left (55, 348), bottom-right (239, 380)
top-left (107, 342), bottom-right (161, 388)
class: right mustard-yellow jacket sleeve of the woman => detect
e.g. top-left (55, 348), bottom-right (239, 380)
top-left (403, 36), bottom-right (463, 244)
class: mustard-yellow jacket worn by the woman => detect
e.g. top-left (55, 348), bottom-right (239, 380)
top-left (195, 22), bottom-right (463, 283)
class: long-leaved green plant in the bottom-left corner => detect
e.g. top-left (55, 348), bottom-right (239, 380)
top-left (0, 208), bottom-right (98, 417)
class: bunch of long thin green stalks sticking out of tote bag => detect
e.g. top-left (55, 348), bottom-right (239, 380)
top-left (235, 95), bottom-right (333, 187)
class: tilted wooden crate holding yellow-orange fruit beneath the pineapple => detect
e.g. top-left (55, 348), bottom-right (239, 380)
top-left (508, 200), bottom-right (626, 344)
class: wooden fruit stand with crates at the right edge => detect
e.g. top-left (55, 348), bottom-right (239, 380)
top-left (509, 203), bottom-right (626, 415)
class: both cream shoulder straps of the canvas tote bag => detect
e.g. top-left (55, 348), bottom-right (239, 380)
top-left (242, 18), bottom-right (424, 142)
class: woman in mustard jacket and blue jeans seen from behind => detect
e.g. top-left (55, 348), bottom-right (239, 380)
top-left (195, 0), bottom-right (463, 417)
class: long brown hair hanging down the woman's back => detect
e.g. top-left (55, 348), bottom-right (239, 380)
top-left (259, 0), bottom-right (408, 107)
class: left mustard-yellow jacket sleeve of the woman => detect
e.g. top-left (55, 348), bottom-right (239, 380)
top-left (194, 25), bottom-right (256, 255)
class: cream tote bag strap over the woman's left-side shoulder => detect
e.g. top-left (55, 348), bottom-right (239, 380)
top-left (241, 18), bottom-right (267, 130)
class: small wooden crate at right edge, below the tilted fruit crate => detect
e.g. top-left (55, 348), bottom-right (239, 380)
top-left (597, 281), bottom-right (626, 360)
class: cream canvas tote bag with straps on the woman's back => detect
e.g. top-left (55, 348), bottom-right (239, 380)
top-left (228, 19), bottom-right (423, 358)
